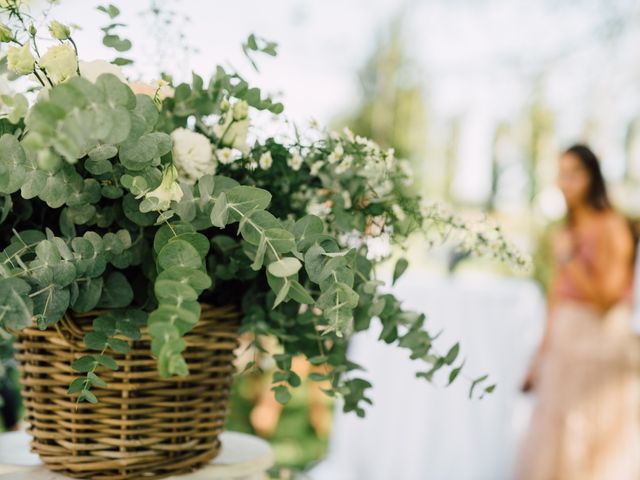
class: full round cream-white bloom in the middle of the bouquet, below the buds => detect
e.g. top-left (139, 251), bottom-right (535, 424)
top-left (171, 128), bottom-right (216, 185)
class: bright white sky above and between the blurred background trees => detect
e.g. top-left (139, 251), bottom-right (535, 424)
top-left (26, 0), bottom-right (640, 210)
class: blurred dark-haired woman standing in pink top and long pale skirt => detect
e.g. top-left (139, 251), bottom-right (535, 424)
top-left (517, 145), bottom-right (640, 480)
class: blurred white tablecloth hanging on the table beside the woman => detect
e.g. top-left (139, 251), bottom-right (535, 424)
top-left (310, 273), bottom-right (544, 480)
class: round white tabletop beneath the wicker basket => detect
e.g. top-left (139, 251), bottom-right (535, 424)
top-left (0, 432), bottom-right (274, 480)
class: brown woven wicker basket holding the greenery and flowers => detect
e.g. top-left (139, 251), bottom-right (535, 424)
top-left (16, 305), bottom-right (239, 480)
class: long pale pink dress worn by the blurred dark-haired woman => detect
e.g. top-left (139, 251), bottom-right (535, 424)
top-left (516, 226), bottom-right (640, 480)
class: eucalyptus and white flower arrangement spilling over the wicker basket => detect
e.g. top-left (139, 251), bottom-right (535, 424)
top-left (0, 0), bottom-right (524, 415)
